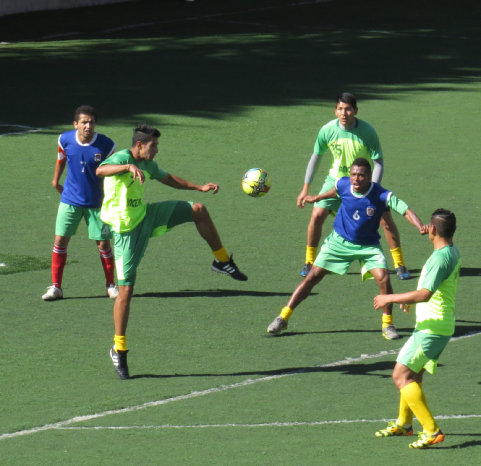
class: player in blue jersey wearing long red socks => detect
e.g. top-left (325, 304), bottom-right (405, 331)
top-left (42, 105), bottom-right (119, 301)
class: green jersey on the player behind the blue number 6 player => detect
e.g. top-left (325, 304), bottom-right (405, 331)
top-left (314, 118), bottom-right (382, 179)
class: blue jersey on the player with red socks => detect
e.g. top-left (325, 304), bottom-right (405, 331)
top-left (58, 130), bottom-right (115, 207)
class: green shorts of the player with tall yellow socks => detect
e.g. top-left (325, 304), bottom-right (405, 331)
top-left (396, 330), bottom-right (451, 374)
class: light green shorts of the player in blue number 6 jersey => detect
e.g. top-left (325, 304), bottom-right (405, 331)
top-left (314, 231), bottom-right (387, 280)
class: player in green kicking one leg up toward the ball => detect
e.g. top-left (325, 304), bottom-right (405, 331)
top-left (97, 125), bottom-right (247, 379)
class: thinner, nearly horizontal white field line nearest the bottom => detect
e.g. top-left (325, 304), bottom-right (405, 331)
top-left (50, 414), bottom-right (481, 430)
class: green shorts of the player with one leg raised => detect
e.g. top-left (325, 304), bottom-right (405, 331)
top-left (112, 201), bottom-right (193, 285)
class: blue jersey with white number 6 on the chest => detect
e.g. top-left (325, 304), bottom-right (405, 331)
top-left (334, 176), bottom-right (392, 246)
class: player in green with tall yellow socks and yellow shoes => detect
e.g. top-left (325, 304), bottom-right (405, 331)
top-left (374, 209), bottom-right (461, 448)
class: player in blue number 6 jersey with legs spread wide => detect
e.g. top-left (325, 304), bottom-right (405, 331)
top-left (267, 158), bottom-right (427, 340)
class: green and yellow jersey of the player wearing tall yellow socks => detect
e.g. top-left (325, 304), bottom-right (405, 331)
top-left (416, 245), bottom-right (461, 336)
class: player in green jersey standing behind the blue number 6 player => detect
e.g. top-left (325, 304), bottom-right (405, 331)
top-left (297, 92), bottom-right (409, 280)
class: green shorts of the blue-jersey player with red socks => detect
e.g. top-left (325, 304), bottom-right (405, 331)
top-left (55, 202), bottom-right (112, 241)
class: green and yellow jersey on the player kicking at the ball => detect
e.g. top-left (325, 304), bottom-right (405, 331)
top-left (100, 149), bottom-right (168, 233)
